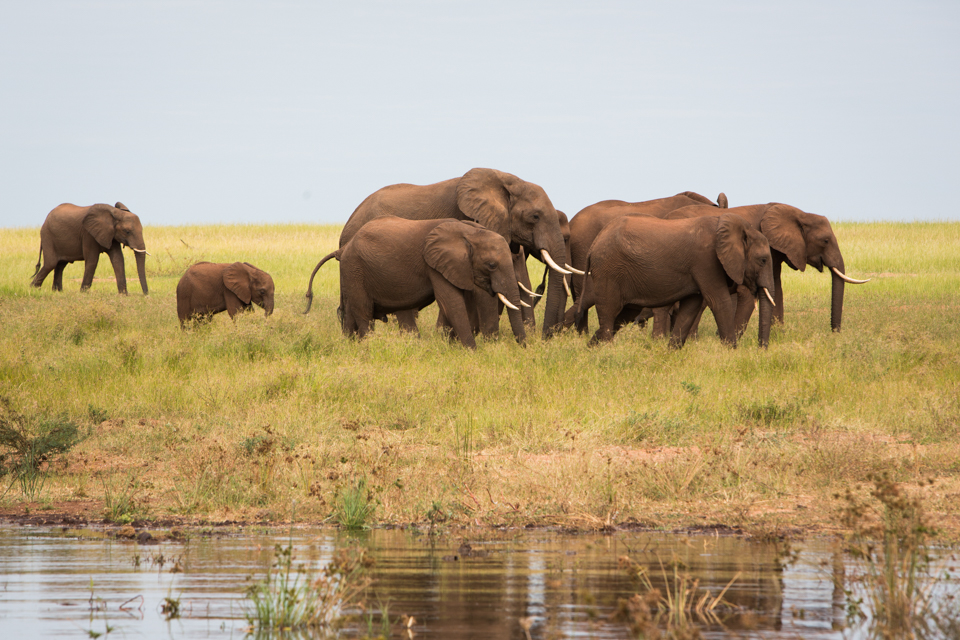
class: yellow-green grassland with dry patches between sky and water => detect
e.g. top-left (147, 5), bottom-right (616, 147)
top-left (0, 223), bottom-right (960, 536)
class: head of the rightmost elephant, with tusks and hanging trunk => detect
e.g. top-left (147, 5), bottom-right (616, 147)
top-left (760, 203), bottom-right (867, 331)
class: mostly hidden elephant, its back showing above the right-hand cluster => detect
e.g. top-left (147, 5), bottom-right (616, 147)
top-left (564, 191), bottom-right (727, 333)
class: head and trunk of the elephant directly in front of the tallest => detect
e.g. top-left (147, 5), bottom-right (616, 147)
top-left (423, 221), bottom-right (526, 344)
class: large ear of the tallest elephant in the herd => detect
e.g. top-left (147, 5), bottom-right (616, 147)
top-left (457, 169), bottom-right (522, 242)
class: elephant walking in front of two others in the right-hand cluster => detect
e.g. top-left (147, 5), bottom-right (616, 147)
top-left (577, 213), bottom-right (774, 348)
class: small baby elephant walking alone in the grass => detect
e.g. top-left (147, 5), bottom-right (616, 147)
top-left (177, 262), bottom-right (273, 329)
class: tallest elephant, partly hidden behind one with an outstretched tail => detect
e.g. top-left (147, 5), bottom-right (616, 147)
top-left (307, 168), bottom-right (570, 337)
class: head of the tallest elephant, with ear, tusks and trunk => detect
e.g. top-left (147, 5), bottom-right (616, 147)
top-left (457, 169), bottom-right (570, 337)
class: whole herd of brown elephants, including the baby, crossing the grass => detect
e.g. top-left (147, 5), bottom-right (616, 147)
top-left (32, 168), bottom-right (866, 348)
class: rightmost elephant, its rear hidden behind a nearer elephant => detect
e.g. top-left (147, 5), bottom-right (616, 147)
top-left (667, 202), bottom-right (869, 345)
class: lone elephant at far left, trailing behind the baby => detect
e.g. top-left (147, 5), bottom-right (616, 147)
top-left (31, 202), bottom-right (150, 295)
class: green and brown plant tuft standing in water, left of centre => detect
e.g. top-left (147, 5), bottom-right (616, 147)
top-left (247, 542), bottom-right (371, 631)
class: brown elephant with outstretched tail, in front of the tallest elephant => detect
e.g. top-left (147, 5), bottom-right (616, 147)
top-left (307, 216), bottom-right (526, 349)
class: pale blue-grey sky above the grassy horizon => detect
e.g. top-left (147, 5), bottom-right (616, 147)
top-left (0, 0), bottom-right (960, 227)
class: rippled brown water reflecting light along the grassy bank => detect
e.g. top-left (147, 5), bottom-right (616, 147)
top-left (0, 526), bottom-right (876, 640)
